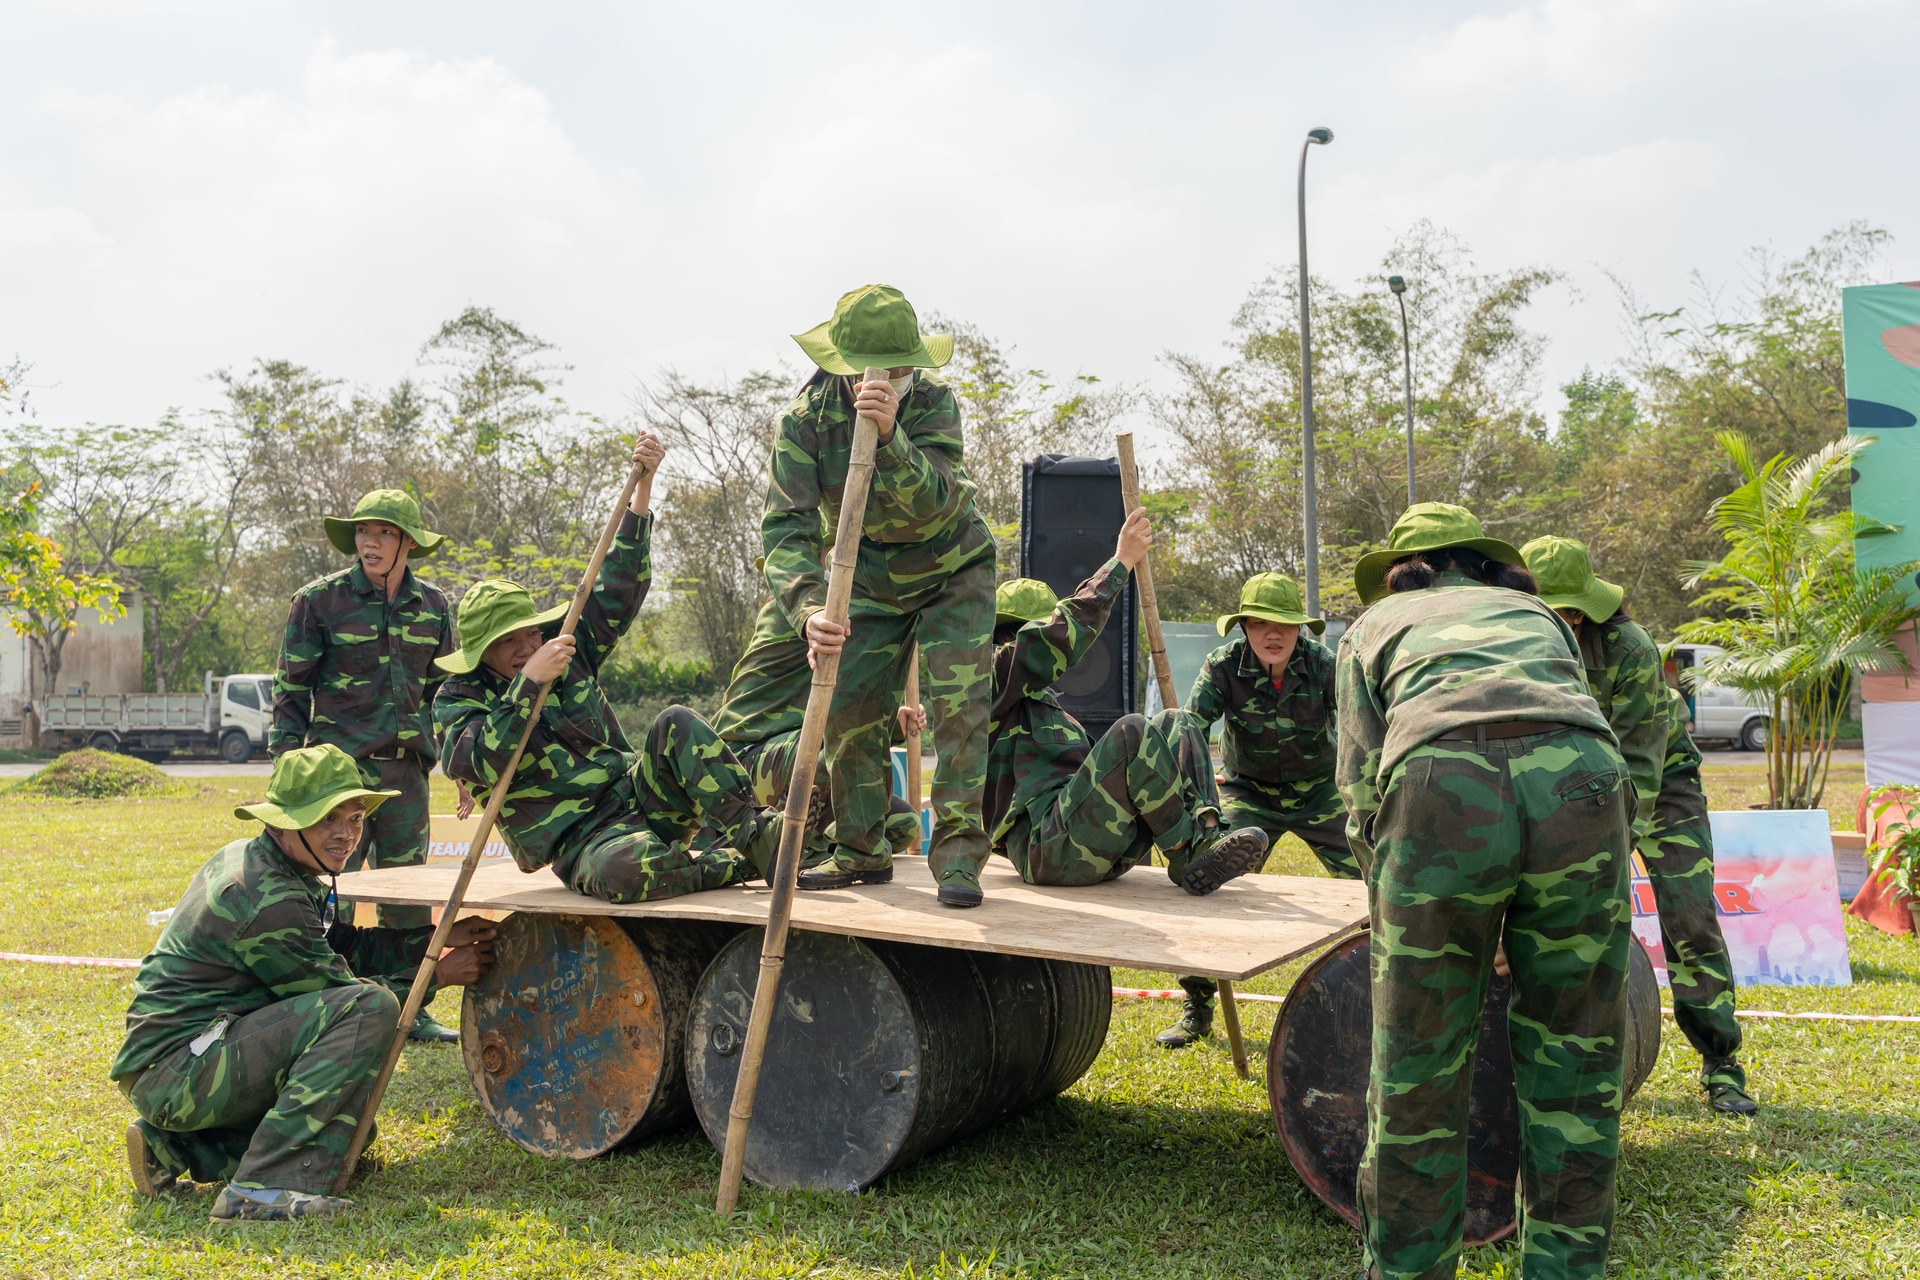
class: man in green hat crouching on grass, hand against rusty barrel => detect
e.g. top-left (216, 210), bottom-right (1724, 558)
top-left (109, 745), bottom-right (493, 1222)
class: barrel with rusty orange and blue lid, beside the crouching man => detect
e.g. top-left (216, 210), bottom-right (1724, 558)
top-left (461, 912), bottom-right (739, 1159)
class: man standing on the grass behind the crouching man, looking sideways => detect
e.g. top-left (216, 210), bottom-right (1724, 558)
top-left (267, 489), bottom-right (459, 1042)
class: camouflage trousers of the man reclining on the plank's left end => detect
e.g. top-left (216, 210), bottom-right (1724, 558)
top-left (553, 706), bottom-right (758, 902)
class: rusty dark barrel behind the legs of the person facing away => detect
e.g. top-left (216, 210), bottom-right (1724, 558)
top-left (1267, 933), bottom-right (1661, 1244)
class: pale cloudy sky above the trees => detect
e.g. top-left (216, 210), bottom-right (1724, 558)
top-left (0, 0), bottom-right (1920, 441)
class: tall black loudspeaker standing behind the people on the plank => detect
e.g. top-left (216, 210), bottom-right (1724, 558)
top-left (1020, 453), bottom-right (1140, 737)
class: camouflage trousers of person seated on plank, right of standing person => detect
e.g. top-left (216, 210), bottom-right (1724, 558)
top-left (1006, 710), bottom-right (1219, 885)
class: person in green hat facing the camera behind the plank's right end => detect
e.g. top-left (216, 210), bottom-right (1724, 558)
top-left (1156, 574), bottom-right (1359, 1050)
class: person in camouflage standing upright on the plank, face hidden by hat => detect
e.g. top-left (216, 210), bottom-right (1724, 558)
top-left (741, 284), bottom-right (995, 908)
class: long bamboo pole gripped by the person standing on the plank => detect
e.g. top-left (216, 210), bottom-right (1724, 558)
top-left (714, 368), bottom-right (887, 1213)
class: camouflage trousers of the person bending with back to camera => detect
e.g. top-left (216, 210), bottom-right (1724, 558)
top-left (1357, 727), bottom-right (1634, 1280)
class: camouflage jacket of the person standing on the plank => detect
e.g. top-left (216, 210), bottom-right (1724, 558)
top-left (760, 370), bottom-right (993, 631)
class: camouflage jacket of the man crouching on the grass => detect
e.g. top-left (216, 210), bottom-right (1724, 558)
top-left (108, 831), bottom-right (434, 1080)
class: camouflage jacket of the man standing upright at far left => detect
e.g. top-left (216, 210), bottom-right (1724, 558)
top-left (267, 560), bottom-right (457, 760)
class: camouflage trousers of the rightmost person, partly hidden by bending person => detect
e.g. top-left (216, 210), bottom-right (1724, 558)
top-left (1640, 766), bottom-right (1747, 1092)
